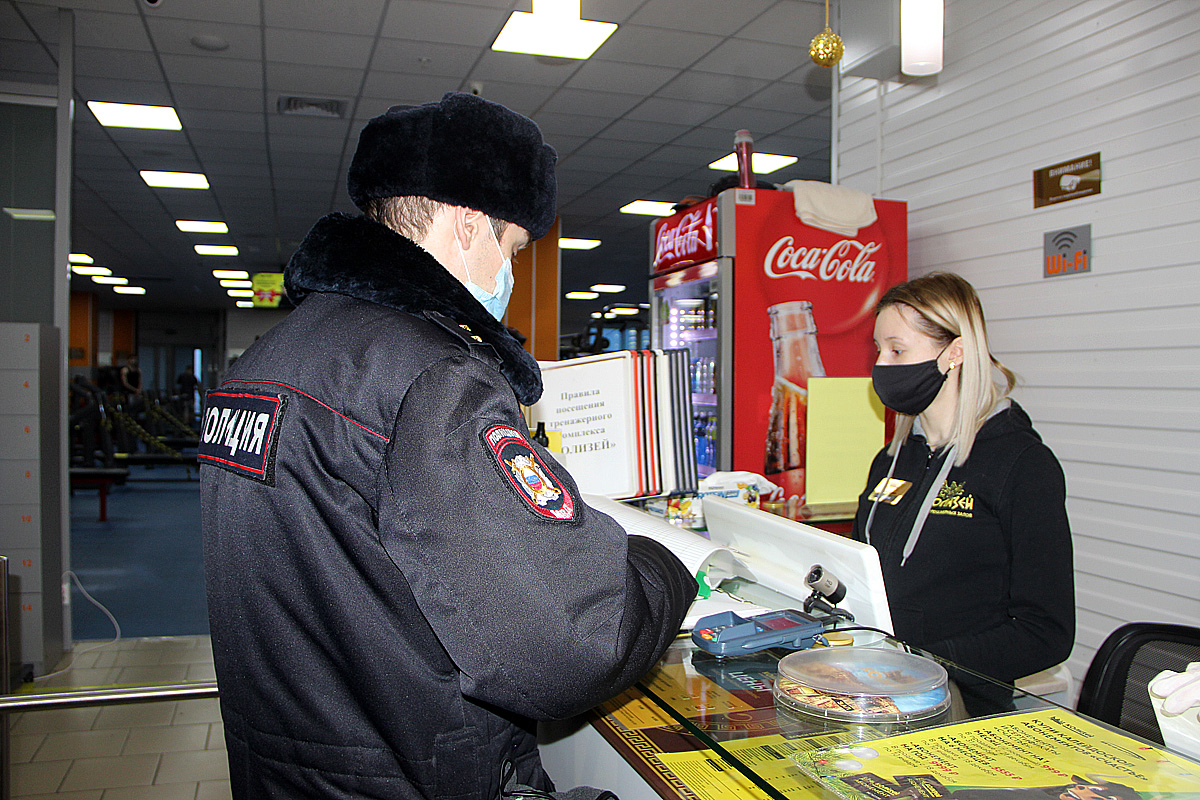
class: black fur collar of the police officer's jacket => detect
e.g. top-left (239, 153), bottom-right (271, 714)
top-left (284, 213), bottom-right (541, 405)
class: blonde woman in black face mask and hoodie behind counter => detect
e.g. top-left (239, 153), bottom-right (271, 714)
top-left (853, 272), bottom-right (1075, 716)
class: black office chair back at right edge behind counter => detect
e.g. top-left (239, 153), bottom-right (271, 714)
top-left (1075, 622), bottom-right (1200, 744)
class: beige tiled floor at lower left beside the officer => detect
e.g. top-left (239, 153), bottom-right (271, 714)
top-left (10, 636), bottom-right (229, 800)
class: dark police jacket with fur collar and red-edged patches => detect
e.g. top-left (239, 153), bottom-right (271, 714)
top-left (200, 215), bottom-right (696, 799)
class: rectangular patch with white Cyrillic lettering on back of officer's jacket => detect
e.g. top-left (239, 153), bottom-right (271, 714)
top-left (198, 390), bottom-right (287, 486)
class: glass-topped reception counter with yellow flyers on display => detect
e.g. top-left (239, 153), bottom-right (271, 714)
top-left (539, 637), bottom-right (1200, 800)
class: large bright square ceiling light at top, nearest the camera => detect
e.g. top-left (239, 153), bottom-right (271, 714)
top-left (492, 0), bottom-right (617, 59)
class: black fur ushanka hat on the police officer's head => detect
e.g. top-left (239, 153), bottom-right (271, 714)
top-left (347, 92), bottom-right (558, 239)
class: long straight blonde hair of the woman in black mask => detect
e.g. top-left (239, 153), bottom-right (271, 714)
top-left (875, 272), bottom-right (1016, 465)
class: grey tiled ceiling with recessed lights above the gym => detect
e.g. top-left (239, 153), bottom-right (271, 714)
top-left (0, 0), bottom-right (830, 331)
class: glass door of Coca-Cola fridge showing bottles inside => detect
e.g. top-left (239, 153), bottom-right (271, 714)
top-left (654, 261), bottom-right (721, 477)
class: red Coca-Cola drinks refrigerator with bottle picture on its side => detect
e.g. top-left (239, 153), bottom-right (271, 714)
top-left (650, 188), bottom-right (908, 507)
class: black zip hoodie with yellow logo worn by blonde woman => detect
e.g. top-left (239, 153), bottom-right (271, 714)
top-left (854, 403), bottom-right (1075, 710)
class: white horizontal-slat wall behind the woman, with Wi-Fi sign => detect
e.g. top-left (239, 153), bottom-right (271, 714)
top-left (838, 0), bottom-right (1200, 678)
